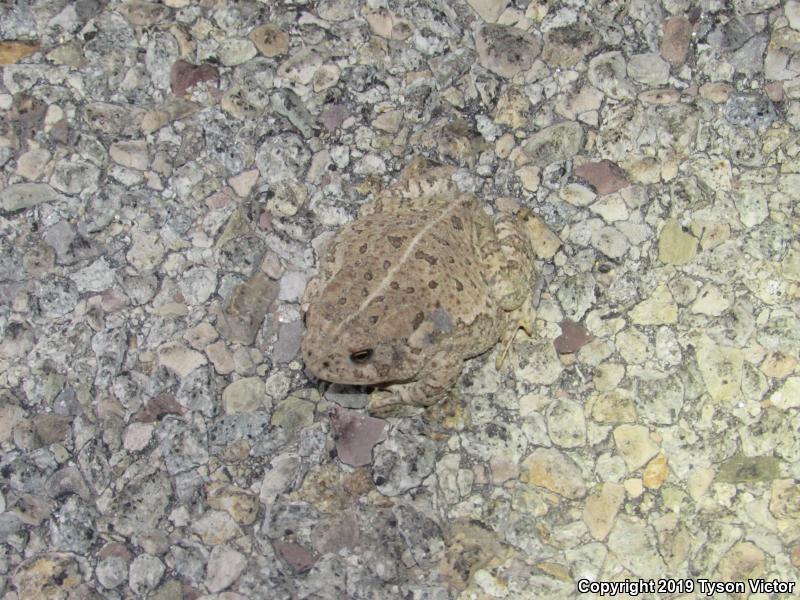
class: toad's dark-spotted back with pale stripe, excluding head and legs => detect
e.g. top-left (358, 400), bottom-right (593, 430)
top-left (323, 197), bottom-right (492, 327)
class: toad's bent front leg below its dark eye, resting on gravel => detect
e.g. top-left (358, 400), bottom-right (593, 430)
top-left (367, 352), bottom-right (464, 417)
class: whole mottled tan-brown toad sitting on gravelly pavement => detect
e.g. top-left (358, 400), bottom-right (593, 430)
top-left (302, 160), bottom-right (533, 412)
